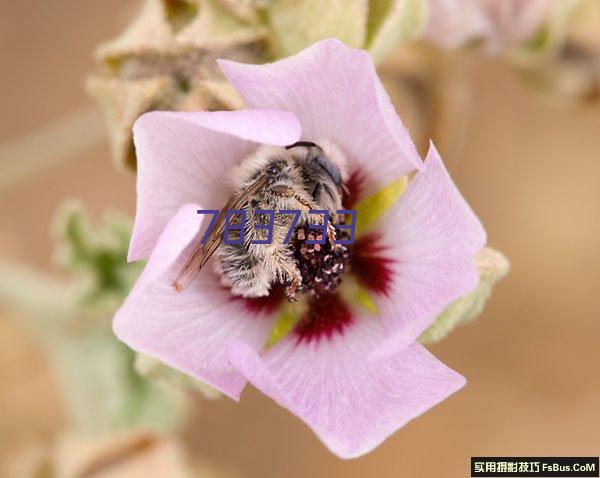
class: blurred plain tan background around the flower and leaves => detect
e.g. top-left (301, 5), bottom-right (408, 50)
top-left (0, 0), bottom-right (600, 478)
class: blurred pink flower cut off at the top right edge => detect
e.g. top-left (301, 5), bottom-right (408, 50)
top-left (426, 0), bottom-right (552, 53)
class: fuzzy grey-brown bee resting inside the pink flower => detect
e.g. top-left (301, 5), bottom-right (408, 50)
top-left (173, 141), bottom-right (345, 300)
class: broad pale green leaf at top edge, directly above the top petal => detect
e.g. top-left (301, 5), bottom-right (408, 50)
top-left (267, 0), bottom-right (369, 57)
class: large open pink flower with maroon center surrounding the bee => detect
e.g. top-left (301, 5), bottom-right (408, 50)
top-left (113, 40), bottom-right (485, 458)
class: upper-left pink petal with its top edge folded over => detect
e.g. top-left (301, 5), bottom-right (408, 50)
top-left (128, 110), bottom-right (300, 261)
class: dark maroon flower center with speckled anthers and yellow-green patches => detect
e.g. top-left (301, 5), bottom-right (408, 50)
top-left (244, 170), bottom-right (395, 345)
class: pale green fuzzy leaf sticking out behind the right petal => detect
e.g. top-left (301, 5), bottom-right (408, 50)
top-left (419, 247), bottom-right (510, 344)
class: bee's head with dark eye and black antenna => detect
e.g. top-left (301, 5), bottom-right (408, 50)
top-left (286, 141), bottom-right (342, 211)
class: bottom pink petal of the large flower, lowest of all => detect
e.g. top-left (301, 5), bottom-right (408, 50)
top-left (227, 319), bottom-right (465, 458)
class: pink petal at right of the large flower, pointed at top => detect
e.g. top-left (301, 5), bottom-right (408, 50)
top-left (373, 144), bottom-right (486, 358)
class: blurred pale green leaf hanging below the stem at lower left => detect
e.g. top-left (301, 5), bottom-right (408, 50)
top-left (50, 325), bottom-right (184, 435)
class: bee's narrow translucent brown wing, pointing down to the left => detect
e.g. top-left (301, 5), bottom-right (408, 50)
top-left (173, 175), bottom-right (267, 291)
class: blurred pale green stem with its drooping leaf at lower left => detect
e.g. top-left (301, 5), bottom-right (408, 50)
top-left (0, 261), bottom-right (185, 435)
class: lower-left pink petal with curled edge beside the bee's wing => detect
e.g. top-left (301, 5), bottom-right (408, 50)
top-left (113, 204), bottom-right (272, 400)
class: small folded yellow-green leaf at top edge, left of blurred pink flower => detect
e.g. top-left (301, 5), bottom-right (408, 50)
top-left (365, 0), bottom-right (428, 63)
